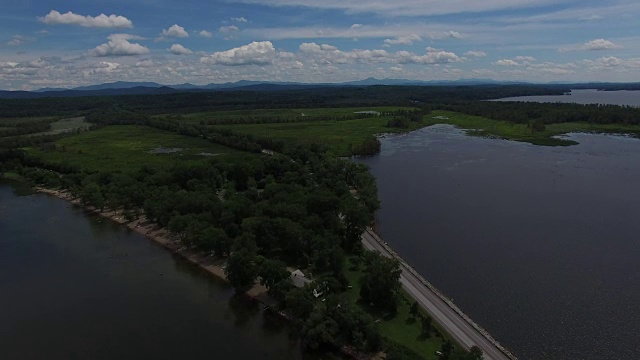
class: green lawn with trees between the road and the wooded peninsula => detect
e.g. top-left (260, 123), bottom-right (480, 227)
top-left (345, 261), bottom-right (444, 360)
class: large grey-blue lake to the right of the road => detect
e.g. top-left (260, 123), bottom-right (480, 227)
top-left (361, 125), bottom-right (640, 360)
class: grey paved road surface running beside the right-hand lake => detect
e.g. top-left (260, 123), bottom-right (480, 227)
top-left (362, 230), bottom-right (510, 360)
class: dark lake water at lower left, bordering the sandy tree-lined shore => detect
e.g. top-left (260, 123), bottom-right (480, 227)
top-left (0, 181), bottom-right (320, 359)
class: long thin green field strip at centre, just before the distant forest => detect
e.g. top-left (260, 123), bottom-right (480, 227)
top-left (162, 106), bottom-right (413, 122)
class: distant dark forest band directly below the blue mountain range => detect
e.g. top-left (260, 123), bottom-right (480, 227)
top-left (0, 85), bottom-right (568, 117)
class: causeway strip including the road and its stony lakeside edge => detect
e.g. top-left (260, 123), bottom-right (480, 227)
top-left (362, 229), bottom-right (516, 360)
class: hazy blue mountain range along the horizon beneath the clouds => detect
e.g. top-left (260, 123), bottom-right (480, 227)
top-left (0, 78), bottom-right (640, 99)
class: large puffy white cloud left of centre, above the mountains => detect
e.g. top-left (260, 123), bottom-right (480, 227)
top-left (200, 41), bottom-right (276, 66)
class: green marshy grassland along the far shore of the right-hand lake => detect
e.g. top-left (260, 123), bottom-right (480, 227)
top-left (424, 111), bottom-right (640, 146)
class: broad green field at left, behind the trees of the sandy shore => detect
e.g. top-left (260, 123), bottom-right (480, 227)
top-left (27, 125), bottom-right (256, 171)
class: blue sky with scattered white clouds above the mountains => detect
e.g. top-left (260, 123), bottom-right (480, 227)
top-left (0, 0), bottom-right (640, 90)
